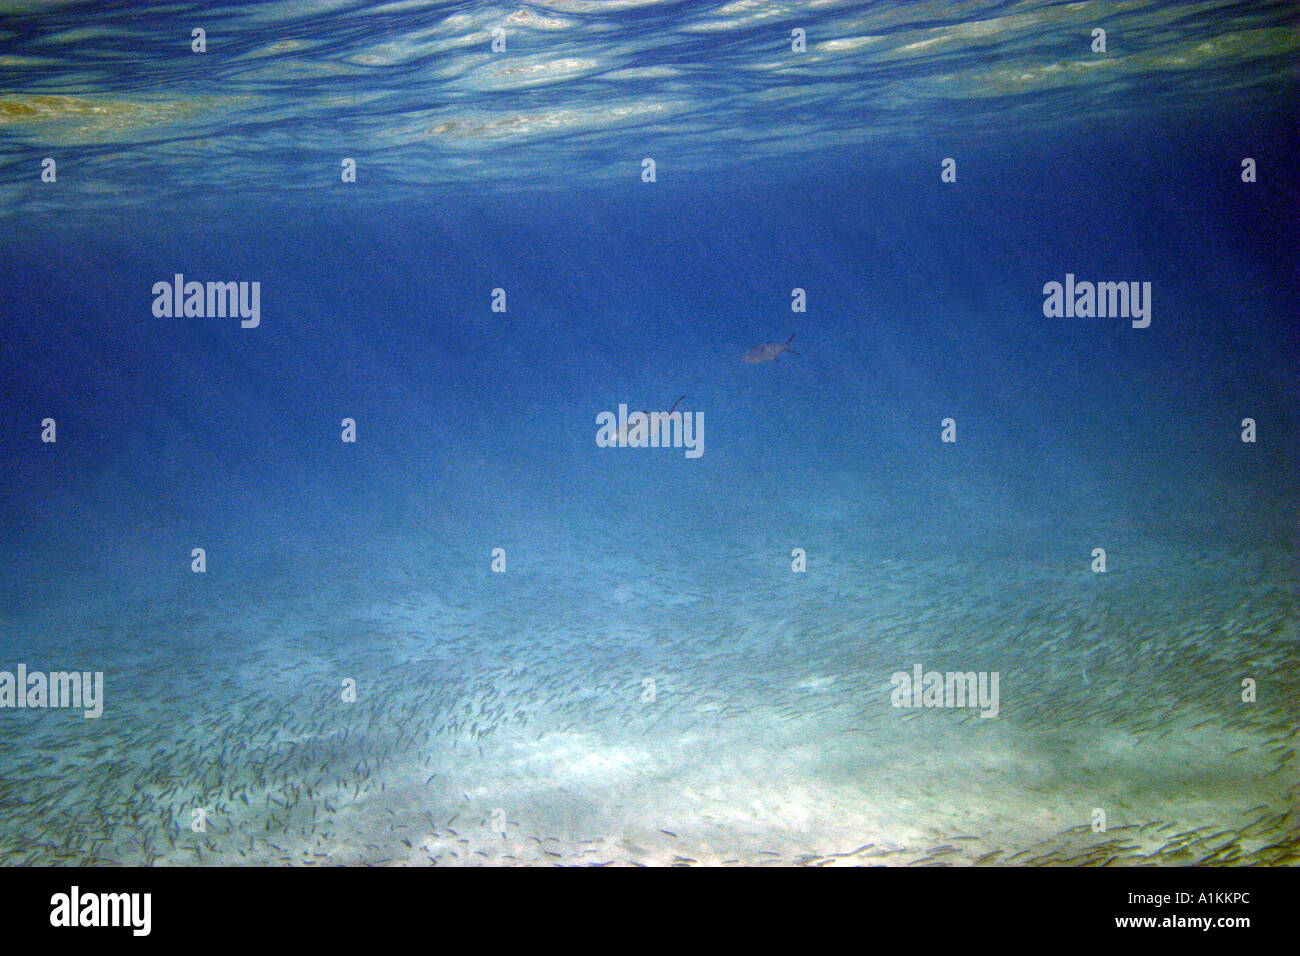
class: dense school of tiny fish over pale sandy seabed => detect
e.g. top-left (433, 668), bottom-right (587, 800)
top-left (0, 519), bottom-right (1300, 866)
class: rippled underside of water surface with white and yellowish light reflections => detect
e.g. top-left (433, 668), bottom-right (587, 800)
top-left (0, 0), bottom-right (1300, 212)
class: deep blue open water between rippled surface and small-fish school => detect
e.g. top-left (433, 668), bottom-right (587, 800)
top-left (4, 119), bottom-right (1300, 590)
